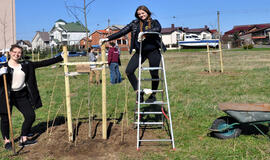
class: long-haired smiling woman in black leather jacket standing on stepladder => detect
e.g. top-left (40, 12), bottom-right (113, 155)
top-left (100, 6), bottom-right (166, 102)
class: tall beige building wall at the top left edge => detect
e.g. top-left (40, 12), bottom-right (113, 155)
top-left (0, 0), bottom-right (16, 50)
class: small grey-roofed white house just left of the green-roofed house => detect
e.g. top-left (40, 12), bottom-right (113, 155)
top-left (32, 31), bottom-right (50, 50)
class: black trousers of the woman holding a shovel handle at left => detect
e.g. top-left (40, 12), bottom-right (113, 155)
top-left (0, 88), bottom-right (36, 139)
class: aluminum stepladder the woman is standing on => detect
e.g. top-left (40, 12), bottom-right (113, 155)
top-left (135, 32), bottom-right (175, 150)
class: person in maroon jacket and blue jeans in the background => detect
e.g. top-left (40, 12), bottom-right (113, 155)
top-left (108, 42), bottom-right (122, 84)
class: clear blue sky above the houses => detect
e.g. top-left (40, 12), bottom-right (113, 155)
top-left (15, 0), bottom-right (270, 41)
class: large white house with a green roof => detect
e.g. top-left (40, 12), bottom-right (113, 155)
top-left (49, 19), bottom-right (86, 46)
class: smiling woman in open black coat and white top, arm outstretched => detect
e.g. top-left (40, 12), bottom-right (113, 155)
top-left (0, 45), bottom-right (63, 149)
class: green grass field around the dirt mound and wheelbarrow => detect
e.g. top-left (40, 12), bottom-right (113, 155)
top-left (0, 50), bottom-right (270, 160)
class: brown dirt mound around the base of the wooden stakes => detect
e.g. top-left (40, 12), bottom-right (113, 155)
top-left (20, 121), bottom-right (169, 160)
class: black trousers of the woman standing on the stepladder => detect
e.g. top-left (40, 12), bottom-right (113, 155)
top-left (126, 49), bottom-right (161, 91)
